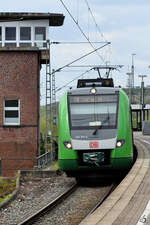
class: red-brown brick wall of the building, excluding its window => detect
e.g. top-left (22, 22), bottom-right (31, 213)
top-left (0, 51), bottom-right (39, 176)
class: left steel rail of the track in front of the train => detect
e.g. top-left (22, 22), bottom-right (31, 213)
top-left (18, 183), bottom-right (78, 225)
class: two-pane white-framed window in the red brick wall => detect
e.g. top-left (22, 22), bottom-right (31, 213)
top-left (4, 99), bottom-right (20, 126)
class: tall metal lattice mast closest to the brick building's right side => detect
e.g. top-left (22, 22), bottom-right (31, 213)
top-left (45, 40), bottom-right (52, 151)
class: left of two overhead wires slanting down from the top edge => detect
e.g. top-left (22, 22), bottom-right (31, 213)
top-left (60, 0), bottom-right (109, 63)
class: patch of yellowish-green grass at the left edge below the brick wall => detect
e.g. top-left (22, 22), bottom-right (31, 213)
top-left (0, 178), bottom-right (16, 203)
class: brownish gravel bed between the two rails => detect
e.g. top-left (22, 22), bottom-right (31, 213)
top-left (34, 183), bottom-right (110, 225)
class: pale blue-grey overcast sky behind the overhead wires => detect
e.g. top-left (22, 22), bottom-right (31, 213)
top-left (0, 0), bottom-right (150, 102)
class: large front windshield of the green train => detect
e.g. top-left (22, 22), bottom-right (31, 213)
top-left (69, 94), bottom-right (118, 129)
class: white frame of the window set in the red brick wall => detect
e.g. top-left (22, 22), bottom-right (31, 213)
top-left (3, 98), bottom-right (20, 126)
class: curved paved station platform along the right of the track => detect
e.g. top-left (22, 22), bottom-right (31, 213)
top-left (80, 132), bottom-right (150, 225)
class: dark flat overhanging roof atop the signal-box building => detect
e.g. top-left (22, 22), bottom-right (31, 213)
top-left (0, 12), bottom-right (64, 26)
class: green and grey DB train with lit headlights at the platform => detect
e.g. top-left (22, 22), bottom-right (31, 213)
top-left (58, 78), bottom-right (134, 178)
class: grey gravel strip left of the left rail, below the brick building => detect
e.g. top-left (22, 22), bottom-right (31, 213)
top-left (0, 175), bottom-right (75, 225)
